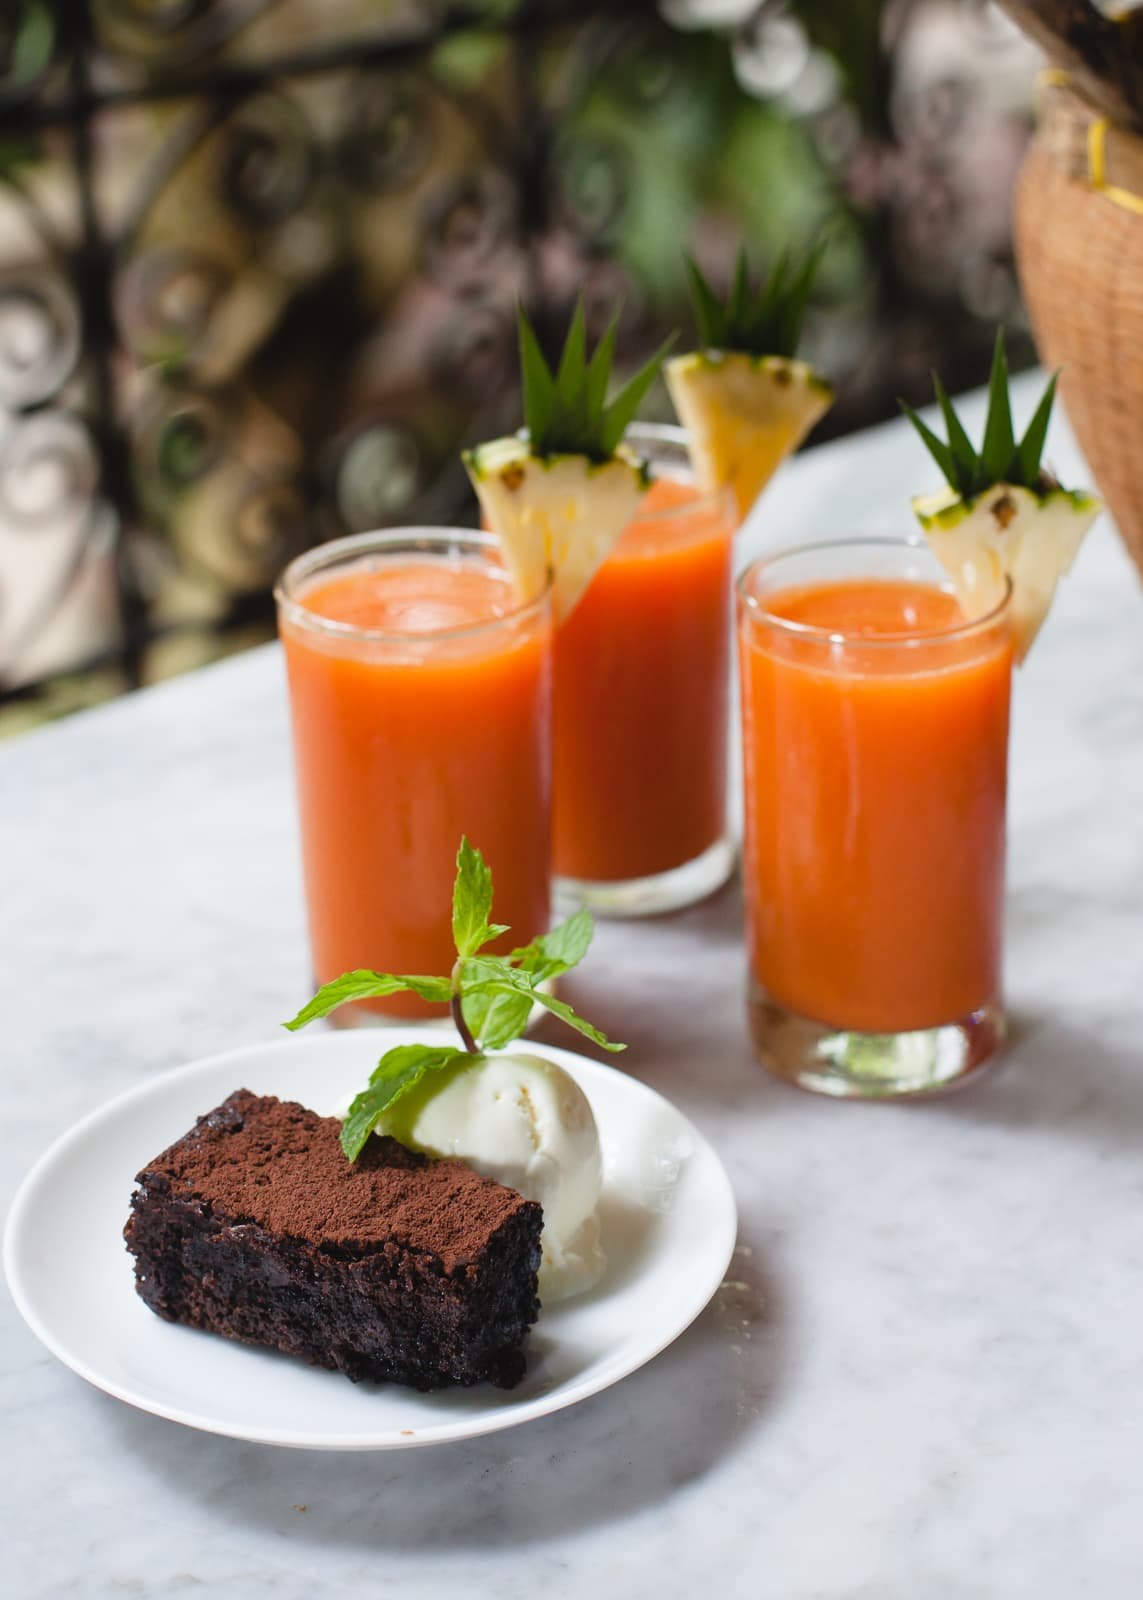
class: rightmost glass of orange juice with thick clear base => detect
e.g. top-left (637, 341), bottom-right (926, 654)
top-left (738, 539), bottom-right (1012, 1098)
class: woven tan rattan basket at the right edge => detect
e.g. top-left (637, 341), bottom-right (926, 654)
top-left (1015, 83), bottom-right (1143, 574)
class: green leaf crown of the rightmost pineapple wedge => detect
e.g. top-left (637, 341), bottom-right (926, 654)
top-left (898, 337), bottom-right (1060, 499)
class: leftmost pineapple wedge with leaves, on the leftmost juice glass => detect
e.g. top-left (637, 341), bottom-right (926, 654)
top-left (464, 301), bottom-right (666, 622)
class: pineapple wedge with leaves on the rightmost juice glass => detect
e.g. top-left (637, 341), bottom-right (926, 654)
top-left (903, 331), bottom-right (1103, 661)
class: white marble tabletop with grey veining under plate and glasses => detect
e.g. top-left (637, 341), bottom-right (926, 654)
top-left (0, 384), bottom-right (1143, 1600)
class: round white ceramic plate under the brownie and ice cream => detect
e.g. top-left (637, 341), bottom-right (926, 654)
top-left (5, 1027), bottom-right (736, 1450)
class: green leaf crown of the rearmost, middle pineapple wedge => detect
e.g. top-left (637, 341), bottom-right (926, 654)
top-left (684, 242), bottom-right (824, 357)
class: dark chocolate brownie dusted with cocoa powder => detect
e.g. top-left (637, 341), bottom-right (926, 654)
top-left (123, 1090), bottom-right (543, 1389)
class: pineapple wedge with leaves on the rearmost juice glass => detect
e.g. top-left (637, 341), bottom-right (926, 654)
top-left (666, 250), bottom-right (834, 520)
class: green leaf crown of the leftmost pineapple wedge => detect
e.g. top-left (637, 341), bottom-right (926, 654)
top-left (519, 296), bottom-right (676, 461)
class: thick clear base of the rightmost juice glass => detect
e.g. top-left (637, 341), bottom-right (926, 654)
top-left (748, 981), bottom-right (1005, 1099)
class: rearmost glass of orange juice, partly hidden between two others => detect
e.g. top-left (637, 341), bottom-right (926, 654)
top-left (552, 426), bottom-right (735, 917)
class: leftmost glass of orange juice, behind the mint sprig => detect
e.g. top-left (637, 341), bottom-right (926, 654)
top-left (277, 528), bottom-right (552, 1022)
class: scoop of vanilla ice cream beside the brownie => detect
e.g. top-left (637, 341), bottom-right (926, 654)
top-left (384, 1054), bottom-right (607, 1301)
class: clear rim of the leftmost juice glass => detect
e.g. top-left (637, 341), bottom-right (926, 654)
top-left (274, 523), bottom-right (554, 645)
